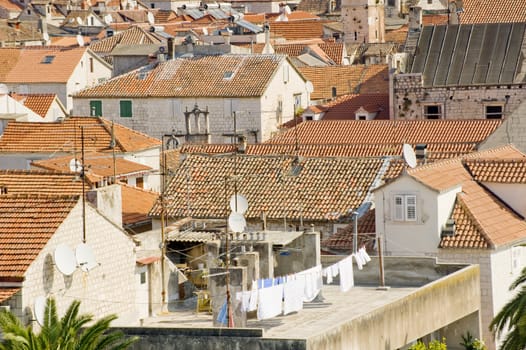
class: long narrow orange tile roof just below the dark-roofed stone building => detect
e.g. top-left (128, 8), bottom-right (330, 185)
top-left (267, 119), bottom-right (502, 144)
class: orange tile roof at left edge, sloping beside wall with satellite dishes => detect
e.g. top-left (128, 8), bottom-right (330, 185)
top-left (0, 195), bottom-right (79, 280)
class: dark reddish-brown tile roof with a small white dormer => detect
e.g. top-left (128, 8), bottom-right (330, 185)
top-left (323, 94), bottom-right (389, 120)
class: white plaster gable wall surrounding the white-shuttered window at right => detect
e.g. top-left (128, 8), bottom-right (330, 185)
top-left (380, 176), bottom-right (445, 256)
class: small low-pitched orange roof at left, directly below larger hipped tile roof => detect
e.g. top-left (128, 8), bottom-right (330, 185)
top-left (31, 152), bottom-right (152, 182)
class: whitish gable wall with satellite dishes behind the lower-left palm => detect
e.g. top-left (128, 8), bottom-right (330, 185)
top-left (23, 201), bottom-right (136, 326)
